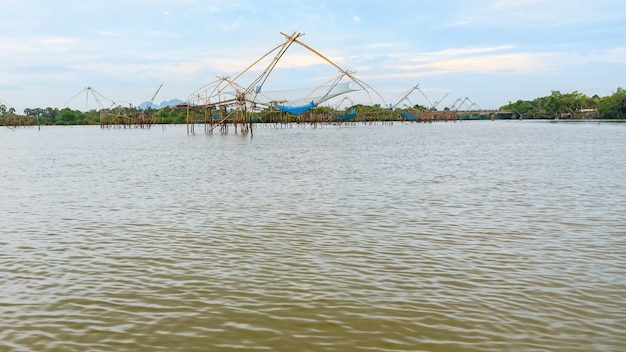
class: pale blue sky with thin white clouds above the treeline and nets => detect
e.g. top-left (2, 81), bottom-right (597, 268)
top-left (0, 0), bottom-right (626, 113)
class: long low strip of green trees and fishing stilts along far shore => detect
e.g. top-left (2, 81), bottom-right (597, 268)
top-left (0, 87), bottom-right (626, 132)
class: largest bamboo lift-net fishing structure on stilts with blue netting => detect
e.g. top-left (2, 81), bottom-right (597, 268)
top-left (179, 32), bottom-right (384, 135)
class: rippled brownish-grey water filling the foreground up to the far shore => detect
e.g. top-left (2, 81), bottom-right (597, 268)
top-left (0, 121), bottom-right (626, 351)
